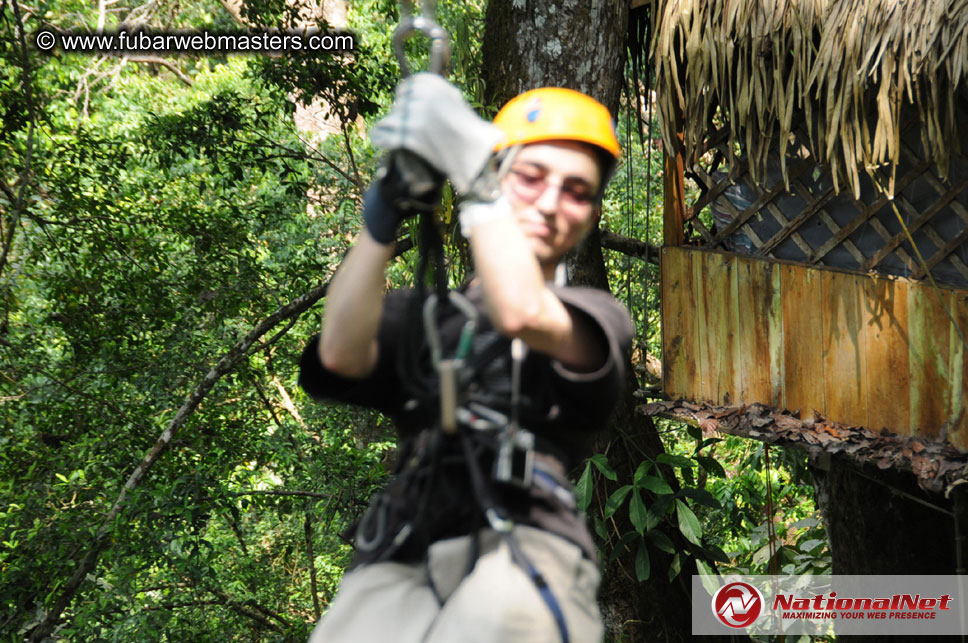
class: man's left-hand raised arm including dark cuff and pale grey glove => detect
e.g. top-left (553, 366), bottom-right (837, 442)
top-left (319, 73), bottom-right (502, 378)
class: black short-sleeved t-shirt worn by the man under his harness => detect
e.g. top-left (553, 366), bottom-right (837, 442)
top-left (299, 286), bottom-right (633, 558)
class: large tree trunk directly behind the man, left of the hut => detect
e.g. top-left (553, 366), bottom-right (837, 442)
top-left (482, 0), bottom-right (712, 641)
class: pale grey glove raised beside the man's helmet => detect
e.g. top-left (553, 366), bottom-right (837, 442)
top-left (370, 73), bottom-right (504, 194)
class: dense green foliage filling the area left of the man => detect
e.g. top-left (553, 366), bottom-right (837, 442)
top-left (0, 3), bottom-right (412, 641)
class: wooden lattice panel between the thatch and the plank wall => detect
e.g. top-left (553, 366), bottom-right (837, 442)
top-left (685, 122), bottom-right (968, 287)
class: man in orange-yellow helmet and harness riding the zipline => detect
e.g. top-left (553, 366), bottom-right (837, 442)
top-left (300, 74), bottom-right (632, 643)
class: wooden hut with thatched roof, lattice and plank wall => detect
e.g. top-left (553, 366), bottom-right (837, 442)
top-left (647, 0), bottom-right (968, 563)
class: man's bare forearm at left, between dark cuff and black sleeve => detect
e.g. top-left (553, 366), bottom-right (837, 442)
top-left (319, 229), bottom-right (393, 378)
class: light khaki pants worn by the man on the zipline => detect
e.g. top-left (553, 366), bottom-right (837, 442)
top-left (309, 527), bottom-right (602, 643)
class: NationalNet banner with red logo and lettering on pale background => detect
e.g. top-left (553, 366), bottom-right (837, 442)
top-left (692, 576), bottom-right (968, 636)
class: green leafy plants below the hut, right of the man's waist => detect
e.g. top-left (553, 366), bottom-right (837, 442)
top-left (577, 421), bottom-right (830, 592)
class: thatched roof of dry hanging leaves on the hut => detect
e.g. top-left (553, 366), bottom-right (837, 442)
top-left (654, 0), bottom-right (968, 199)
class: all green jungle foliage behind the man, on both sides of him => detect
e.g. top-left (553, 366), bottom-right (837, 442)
top-left (0, 0), bottom-right (825, 641)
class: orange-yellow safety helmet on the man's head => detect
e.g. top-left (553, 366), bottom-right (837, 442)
top-left (494, 87), bottom-right (622, 159)
